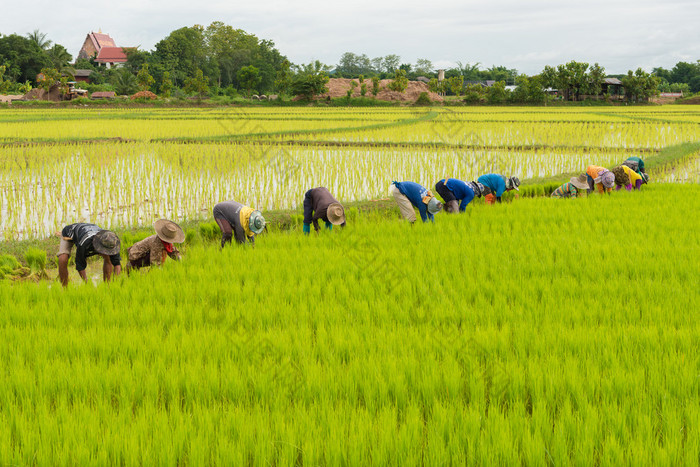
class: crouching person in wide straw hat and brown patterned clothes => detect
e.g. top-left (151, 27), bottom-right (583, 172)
top-left (126, 219), bottom-right (185, 272)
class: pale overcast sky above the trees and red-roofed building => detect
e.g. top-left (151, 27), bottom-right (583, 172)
top-left (0, 0), bottom-right (700, 74)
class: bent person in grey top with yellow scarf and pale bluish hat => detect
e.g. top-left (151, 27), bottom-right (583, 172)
top-left (214, 200), bottom-right (265, 248)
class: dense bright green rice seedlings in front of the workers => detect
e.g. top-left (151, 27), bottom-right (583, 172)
top-left (0, 185), bottom-right (700, 466)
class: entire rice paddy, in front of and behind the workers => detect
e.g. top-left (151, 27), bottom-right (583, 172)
top-left (0, 106), bottom-right (700, 466)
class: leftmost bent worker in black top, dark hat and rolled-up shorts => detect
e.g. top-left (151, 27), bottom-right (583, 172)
top-left (56, 223), bottom-right (121, 287)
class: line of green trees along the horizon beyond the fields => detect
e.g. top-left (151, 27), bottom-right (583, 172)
top-left (0, 26), bottom-right (700, 103)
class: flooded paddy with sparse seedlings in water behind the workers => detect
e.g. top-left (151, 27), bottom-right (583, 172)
top-left (0, 147), bottom-right (680, 240)
